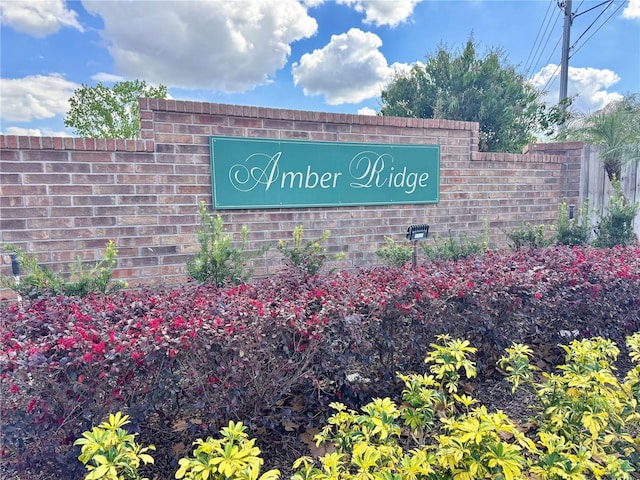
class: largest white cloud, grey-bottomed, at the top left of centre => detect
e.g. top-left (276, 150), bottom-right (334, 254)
top-left (83, 0), bottom-right (318, 92)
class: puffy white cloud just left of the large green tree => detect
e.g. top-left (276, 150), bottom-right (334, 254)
top-left (291, 28), bottom-right (410, 105)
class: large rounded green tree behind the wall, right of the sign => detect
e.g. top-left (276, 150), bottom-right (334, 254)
top-left (380, 38), bottom-right (557, 152)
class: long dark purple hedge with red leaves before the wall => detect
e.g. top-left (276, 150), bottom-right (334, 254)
top-left (0, 245), bottom-right (640, 478)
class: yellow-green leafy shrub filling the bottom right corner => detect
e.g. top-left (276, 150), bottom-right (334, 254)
top-left (499, 333), bottom-right (640, 480)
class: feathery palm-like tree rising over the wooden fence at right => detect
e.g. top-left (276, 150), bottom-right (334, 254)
top-left (567, 93), bottom-right (640, 180)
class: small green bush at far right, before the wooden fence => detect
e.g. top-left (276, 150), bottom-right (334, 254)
top-left (593, 178), bottom-right (638, 248)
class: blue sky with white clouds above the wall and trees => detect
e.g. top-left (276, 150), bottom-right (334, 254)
top-left (0, 0), bottom-right (640, 135)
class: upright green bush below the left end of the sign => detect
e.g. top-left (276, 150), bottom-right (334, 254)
top-left (187, 201), bottom-right (269, 287)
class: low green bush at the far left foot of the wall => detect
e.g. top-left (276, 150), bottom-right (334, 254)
top-left (2, 240), bottom-right (127, 298)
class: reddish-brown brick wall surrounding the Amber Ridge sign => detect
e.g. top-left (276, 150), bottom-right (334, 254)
top-left (0, 99), bottom-right (582, 290)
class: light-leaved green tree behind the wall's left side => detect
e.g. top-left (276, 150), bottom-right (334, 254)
top-left (64, 80), bottom-right (167, 138)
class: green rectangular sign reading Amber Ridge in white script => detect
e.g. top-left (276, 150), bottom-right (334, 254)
top-left (211, 137), bottom-right (440, 209)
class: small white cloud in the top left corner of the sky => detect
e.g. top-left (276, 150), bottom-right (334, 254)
top-left (0, 0), bottom-right (84, 38)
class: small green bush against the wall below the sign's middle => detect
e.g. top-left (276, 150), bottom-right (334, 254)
top-left (278, 225), bottom-right (344, 276)
